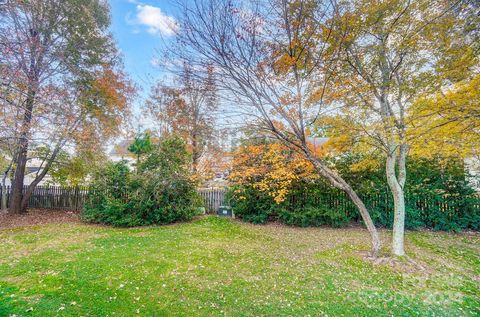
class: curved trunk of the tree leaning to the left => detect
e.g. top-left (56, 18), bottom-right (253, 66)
top-left (307, 154), bottom-right (381, 257)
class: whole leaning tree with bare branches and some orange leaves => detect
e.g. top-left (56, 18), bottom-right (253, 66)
top-left (171, 0), bottom-right (380, 255)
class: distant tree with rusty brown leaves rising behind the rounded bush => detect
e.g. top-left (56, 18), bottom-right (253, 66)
top-left (146, 63), bottom-right (218, 173)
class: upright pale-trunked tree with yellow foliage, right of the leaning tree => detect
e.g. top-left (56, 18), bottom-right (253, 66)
top-left (332, 0), bottom-right (478, 256)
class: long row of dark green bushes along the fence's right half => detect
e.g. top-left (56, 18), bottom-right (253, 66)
top-left (230, 156), bottom-right (480, 231)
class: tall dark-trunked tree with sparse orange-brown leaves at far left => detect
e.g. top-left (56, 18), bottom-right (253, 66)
top-left (0, 0), bottom-right (132, 212)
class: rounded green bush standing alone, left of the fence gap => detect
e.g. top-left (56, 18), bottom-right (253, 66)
top-left (83, 138), bottom-right (202, 227)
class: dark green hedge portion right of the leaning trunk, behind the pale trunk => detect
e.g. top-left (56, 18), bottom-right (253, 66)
top-left (336, 155), bottom-right (480, 231)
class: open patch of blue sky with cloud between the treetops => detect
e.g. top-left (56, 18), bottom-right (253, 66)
top-left (109, 0), bottom-right (176, 109)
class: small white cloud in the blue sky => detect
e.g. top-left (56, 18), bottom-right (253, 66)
top-left (136, 4), bottom-right (178, 36)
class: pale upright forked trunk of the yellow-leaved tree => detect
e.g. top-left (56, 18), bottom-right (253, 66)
top-left (386, 145), bottom-right (406, 256)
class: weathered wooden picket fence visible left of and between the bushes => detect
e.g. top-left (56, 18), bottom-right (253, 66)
top-left (0, 186), bottom-right (226, 213)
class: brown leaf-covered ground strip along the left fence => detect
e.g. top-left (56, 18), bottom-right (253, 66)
top-left (0, 209), bottom-right (81, 229)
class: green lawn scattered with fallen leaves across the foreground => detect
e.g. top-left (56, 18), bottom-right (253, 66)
top-left (0, 217), bottom-right (480, 316)
